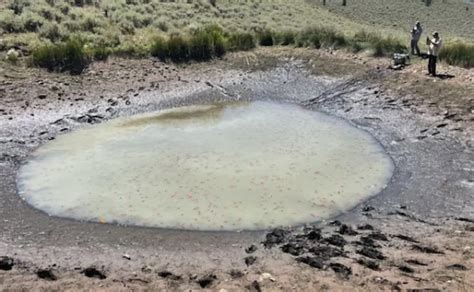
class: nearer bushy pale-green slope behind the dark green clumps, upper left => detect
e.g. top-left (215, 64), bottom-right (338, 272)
top-left (0, 0), bottom-right (370, 51)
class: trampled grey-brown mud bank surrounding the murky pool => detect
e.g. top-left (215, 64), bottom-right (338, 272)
top-left (0, 52), bottom-right (474, 291)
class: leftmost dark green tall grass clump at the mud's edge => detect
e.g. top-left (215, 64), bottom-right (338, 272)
top-left (31, 38), bottom-right (90, 74)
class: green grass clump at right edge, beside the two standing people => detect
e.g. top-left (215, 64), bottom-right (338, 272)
top-left (439, 42), bottom-right (474, 69)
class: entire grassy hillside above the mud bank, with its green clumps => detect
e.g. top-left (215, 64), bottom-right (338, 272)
top-left (0, 0), bottom-right (474, 69)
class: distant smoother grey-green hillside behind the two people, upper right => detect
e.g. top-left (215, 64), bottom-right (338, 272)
top-left (311, 0), bottom-right (474, 40)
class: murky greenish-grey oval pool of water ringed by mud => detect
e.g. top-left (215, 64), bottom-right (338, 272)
top-left (18, 102), bottom-right (393, 230)
